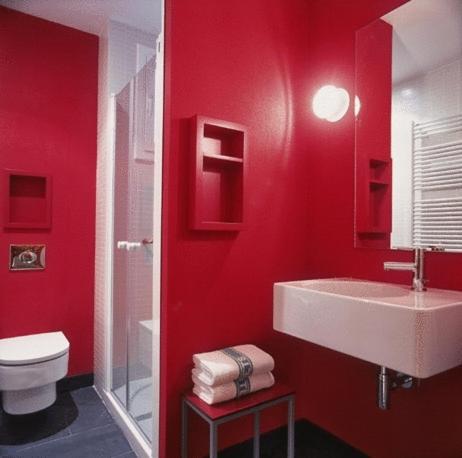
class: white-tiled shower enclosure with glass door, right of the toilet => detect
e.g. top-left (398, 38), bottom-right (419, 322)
top-left (95, 0), bottom-right (164, 457)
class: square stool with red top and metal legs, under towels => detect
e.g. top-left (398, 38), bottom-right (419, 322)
top-left (181, 383), bottom-right (295, 458)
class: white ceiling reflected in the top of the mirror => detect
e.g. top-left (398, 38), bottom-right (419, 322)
top-left (382, 0), bottom-right (462, 83)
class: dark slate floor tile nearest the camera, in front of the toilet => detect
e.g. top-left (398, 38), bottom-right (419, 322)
top-left (13, 424), bottom-right (131, 458)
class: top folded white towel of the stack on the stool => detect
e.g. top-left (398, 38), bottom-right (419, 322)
top-left (193, 345), bottom-right (274, 386)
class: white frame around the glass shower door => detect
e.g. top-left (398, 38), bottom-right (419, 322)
top-left (100, 8), bottom-right (166, 458)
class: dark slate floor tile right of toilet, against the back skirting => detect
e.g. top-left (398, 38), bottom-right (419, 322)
top-left (70, 387), bottom-right (114, 434)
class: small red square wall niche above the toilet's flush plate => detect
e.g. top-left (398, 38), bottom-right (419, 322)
top-left (3, 170), bottom-right (51, 229)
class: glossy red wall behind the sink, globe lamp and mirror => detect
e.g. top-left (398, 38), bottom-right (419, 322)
top-left (302, 0), bottom-right (462, 458)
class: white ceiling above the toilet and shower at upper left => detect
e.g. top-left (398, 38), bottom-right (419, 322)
top-left (0, 0), bottom-right (161, 35)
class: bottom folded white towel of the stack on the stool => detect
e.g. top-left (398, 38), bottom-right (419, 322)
top-left (193, 372), bottom-right (274, 404)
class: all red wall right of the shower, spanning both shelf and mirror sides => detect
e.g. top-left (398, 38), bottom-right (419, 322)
top-left (161, 0), bottom-right (462, 458)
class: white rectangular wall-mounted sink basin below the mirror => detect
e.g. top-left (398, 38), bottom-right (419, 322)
top-left (273, 278), bottom-right (462, 378)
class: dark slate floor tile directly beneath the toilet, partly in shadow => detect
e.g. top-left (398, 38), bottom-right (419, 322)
top-left (0, 393), bottom-right (78, 456)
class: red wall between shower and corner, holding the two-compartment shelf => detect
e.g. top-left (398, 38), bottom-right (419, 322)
top-left (161, 0), bottom-right (309, 458)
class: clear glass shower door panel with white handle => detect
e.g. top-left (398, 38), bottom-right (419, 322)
top-left (112, 56), bottom-right (157, 441)
